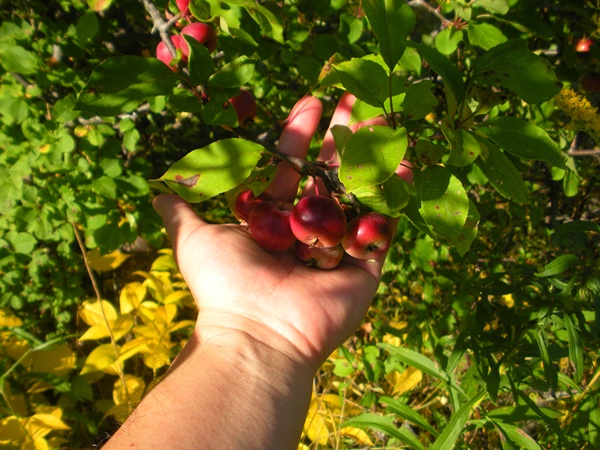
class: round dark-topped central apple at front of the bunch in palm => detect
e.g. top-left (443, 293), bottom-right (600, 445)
top-left (290, 195), bottom-right (346, 247)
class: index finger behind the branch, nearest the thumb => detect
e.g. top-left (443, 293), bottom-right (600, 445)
top-left (267, 96), bottom-right (323, 201)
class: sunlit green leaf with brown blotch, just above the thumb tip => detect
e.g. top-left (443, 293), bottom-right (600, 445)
top-left (160, 138), bottom-right (265, 203)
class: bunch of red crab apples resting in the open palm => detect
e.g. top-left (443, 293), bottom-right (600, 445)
top-left (233, 190), bottom-right (394, 269)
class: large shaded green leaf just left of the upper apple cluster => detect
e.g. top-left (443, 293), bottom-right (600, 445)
top-left (75, 56), bottom-right (178, 116)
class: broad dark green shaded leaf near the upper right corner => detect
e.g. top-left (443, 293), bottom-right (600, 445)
top-left (472, 39), bottom-right (562, 103)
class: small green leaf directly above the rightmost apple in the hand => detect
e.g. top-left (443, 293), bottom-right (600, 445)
top-left (352, 175), bottom-right (410, 217)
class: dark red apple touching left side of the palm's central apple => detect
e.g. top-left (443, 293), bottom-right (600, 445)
top-left (248, 202), bottom-right (296, 252)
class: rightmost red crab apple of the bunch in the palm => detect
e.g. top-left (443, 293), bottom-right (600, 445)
top-left (342, 212), bottom-right (394, 259)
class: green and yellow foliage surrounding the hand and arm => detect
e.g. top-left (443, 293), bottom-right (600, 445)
top-left (0, 0), bottom-right (600, 449)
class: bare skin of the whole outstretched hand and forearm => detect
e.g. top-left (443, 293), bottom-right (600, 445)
top-left (104, 94), bottom-right (394, 450)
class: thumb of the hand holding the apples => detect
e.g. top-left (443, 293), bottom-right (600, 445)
top-left (152, 194), bottom-right (208, 258)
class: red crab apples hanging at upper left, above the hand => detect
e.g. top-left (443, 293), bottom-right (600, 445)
top-left (156, 0), bottom-right (256, 127)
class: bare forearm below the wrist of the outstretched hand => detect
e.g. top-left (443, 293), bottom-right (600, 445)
top-left (105, 314), bottom-right (312, 450)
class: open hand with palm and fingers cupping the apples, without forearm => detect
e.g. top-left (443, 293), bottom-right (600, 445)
top-left (154, 94), bottom-right (392, 372)
